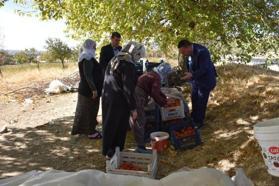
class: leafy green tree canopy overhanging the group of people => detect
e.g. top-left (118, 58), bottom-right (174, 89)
top-left (12, 0), bottom-right (279, 62)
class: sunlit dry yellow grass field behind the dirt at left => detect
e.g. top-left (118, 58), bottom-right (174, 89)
top-left (0, 63), bottom-right (77, 101)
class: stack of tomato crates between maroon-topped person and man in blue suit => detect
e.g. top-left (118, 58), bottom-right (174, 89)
top-left (145, 88), bottom-right (201, 149)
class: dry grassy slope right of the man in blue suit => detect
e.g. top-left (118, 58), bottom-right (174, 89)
top-left (162, 65), bottom-right (279, 186)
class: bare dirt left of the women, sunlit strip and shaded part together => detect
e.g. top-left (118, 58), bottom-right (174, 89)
top-left (0, 93), bottom-right (104, 178)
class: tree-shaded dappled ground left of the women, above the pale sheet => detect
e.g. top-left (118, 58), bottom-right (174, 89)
top-left (0, 117), bottom-right (105, 178)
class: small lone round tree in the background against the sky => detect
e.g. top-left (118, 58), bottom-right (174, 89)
top-left (46, 38), bottom-right (72, 68)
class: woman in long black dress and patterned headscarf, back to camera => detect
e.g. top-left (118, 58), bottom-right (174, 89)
top-left (102, 41), bottom-right (145, 158)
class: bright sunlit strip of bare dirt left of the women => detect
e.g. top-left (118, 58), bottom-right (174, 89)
top-left (0, 93), bottom-right (77, 128)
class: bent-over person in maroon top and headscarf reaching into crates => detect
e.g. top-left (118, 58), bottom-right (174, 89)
top-left (131, 63), bottom-right (172, 153)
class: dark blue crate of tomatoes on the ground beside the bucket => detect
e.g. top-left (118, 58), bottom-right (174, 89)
top-left (168, 120), bottom-right (201, 150)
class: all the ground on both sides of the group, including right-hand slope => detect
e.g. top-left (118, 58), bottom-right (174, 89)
top-left (0, 65), bottom-right (279, 186)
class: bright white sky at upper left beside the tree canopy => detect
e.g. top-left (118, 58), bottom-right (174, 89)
top-left (0, 1), bottom-right (78, 50)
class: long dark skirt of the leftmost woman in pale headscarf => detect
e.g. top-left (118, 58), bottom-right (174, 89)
top-left (72, 94), bottom-right (100, 135)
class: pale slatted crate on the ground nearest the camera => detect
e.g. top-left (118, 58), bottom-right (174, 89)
top-left (106, 147), bottom-right (158, 178)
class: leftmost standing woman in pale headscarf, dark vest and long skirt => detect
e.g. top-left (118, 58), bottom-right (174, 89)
top-left (72, 39), bottom-right (103, 139)
